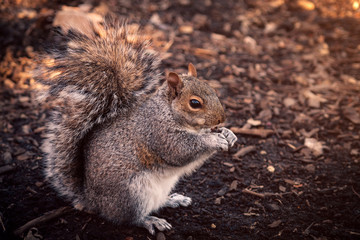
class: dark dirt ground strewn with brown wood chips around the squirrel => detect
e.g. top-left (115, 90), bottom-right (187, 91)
top-left (0, 0), bottom-right (360, 240)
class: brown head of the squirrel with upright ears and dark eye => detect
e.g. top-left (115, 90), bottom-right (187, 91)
top-left (166, 63), bottom-right (225, 129)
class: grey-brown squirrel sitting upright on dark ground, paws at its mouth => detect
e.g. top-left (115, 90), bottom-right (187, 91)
top-left (37, 18), bottom-right (237, 234)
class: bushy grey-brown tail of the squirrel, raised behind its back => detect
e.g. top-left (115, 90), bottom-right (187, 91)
top-left (37, 20), bottom-right (163, 205)
